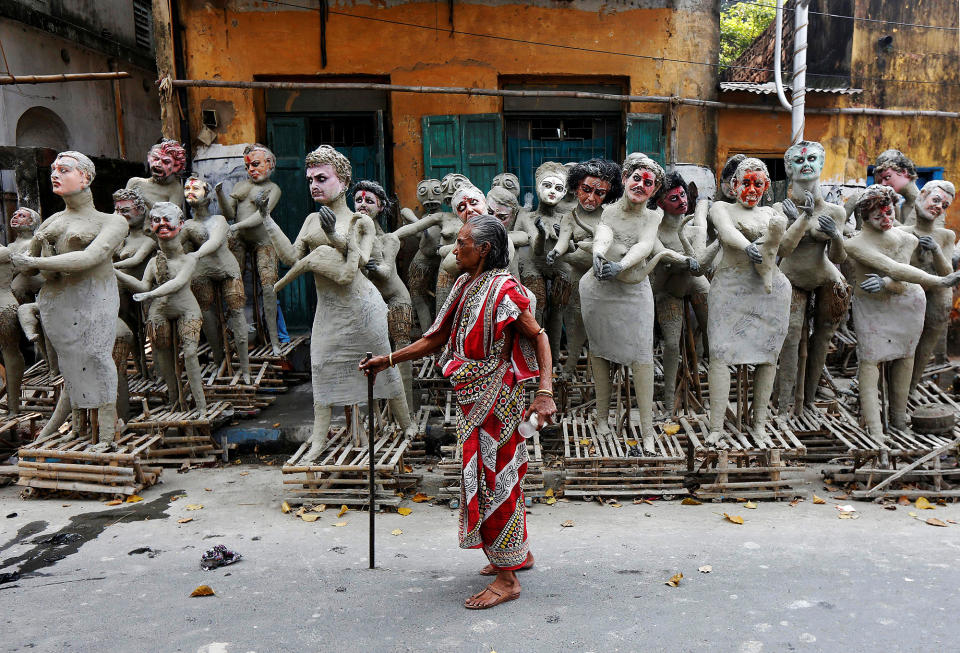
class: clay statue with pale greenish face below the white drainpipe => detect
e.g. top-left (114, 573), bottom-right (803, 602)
top-left (774, 141), bottom-right (850, 414)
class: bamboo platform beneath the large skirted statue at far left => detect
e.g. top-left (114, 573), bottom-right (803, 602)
top-left (17, 426), bottom-right (163, 499)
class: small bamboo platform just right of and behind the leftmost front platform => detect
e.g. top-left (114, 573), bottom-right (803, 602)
top-left (127, 401), bottom-right (233, 467)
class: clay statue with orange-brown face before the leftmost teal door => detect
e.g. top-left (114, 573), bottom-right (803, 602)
top-left (216, 143), bottom-right (280, 356)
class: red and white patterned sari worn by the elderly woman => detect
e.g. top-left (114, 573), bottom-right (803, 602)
top-left (424, 269), bottom-right (538, 569)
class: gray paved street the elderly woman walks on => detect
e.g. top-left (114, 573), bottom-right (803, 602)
top-left (0, 464), bottom-right (960, 653)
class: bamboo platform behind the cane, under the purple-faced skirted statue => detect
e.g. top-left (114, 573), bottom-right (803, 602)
top-left (280, 426), bottom-right (417, 506)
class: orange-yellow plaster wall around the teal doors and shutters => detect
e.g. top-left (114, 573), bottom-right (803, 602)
top-left (174, 0), bottom-right (719, 200)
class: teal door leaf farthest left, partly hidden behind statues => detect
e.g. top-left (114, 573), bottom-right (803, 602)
top-left (267, 116), bottom-right (317, 330)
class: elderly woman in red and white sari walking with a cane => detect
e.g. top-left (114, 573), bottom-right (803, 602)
top-left (360, 213), bottom-right (557, 610)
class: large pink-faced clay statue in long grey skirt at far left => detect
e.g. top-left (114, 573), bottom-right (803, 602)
top-left (11, 151), bottom-right (128, 448)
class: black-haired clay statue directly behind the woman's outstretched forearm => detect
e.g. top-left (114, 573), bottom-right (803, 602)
top-left (353, 179), bottom-right (414, 409)
